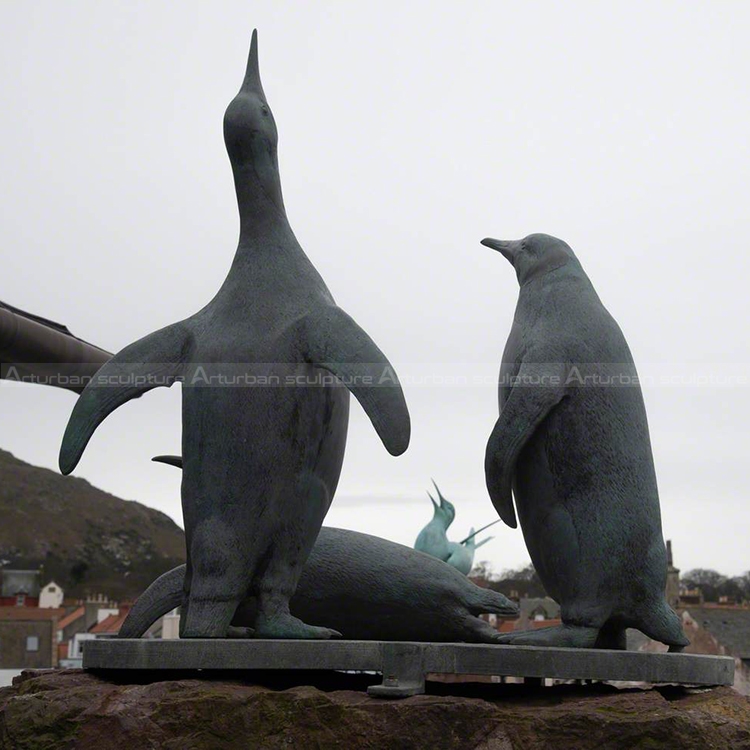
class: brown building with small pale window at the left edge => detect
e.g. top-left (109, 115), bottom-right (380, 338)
top-left (0, 606), bottom-right (65, 669)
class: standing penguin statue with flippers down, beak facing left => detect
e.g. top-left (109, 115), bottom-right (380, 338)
top-left (482, 234), bottom-right (688, 650)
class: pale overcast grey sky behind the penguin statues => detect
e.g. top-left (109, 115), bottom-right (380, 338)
top-left (0, 0), bottom-right (750, 573)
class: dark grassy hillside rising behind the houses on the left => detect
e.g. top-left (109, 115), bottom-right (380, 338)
top-left (0, 450), bottom-right (185, 601)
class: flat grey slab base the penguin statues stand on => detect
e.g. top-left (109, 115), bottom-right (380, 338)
top-left (83, 638), bottom-right (734, 698)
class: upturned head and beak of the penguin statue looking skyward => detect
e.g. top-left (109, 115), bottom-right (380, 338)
top-left (224, 30), bottom-right (283, 206)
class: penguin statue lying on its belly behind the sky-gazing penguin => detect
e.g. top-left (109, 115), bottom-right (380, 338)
top-left (119, 526), bottom-right (518, 643)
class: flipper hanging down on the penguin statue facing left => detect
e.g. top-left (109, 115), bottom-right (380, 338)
top-left (484, 363), bottom-right (565, 529)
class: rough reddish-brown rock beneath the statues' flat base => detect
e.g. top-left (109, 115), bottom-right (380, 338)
top-left (0, 670), bottom-right (750, 750)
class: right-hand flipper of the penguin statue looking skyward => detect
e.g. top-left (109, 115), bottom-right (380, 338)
top-left (302, 305), bottom-right (411, 456)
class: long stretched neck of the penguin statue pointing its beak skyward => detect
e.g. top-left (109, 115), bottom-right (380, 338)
top-left (232, 162), bottom-right (289, 248)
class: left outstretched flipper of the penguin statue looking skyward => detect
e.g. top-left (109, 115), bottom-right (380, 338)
top-left (60, 323), bottom-right (192, 474)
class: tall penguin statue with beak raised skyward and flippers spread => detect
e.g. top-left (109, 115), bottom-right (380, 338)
top-left (60, 32), bottom-right (410, 638)
